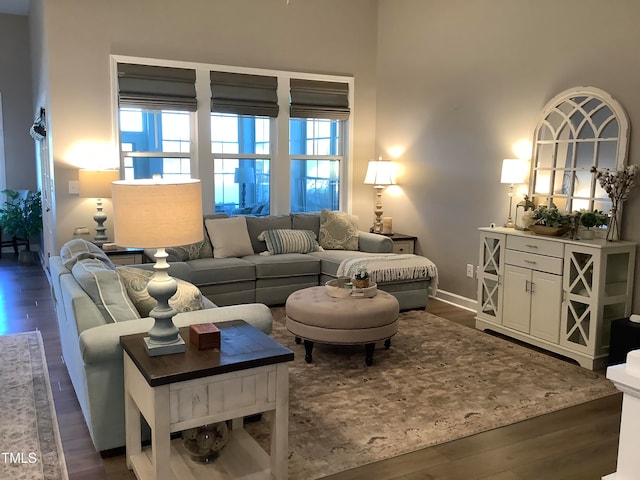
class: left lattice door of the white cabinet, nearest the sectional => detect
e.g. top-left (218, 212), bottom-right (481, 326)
top-left (478, 232), bottom-right (506, 323)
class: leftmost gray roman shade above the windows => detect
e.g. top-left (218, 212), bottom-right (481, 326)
top-left (118, 63), bottom-right (198, 112)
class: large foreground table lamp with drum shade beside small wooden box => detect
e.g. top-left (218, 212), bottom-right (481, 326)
top-left (112, 178), bottom-right (202, 357)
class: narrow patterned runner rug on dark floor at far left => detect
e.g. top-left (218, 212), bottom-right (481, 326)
top-left (0, 331), bottom-right (68, 480)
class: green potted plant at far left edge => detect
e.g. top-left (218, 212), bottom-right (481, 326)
top-left (0, 190), bottom-right (42, 263)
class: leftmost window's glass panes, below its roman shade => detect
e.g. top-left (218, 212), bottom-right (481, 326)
top-left (120, 107), bottom-right (191, 180)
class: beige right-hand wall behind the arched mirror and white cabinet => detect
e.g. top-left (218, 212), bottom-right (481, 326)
top-left (376, 0), bottom-right (640, 312)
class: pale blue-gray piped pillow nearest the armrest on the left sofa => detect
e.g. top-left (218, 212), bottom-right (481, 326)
top-left (71, 258), bottom-right (140, 323)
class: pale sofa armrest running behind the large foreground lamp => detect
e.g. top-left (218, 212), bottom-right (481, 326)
top-left (78, 303), bottom-right (273, 364)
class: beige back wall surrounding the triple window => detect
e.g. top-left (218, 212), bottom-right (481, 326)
top-left (40, 0), bottom-right (377, 253)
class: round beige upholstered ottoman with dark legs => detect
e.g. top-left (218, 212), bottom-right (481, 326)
top-left (285, 286), bottom-right (400, 365)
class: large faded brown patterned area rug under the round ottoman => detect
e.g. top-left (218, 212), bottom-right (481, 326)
top-left (245, 308), bottom-right (617, 480)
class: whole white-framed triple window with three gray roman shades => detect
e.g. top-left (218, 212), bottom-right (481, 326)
top-left (113, 56), bottom-right (353, 215)
